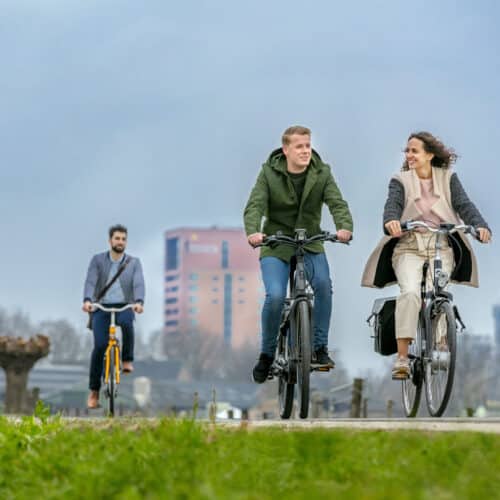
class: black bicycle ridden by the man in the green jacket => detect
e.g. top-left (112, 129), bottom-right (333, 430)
top-left (257, 229), bottom-right (348, 419)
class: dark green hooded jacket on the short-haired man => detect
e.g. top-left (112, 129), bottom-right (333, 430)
top-left (243, 148), bottom-right (353, 262)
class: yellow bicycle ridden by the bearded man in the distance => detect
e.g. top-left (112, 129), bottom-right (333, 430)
top-left (92, 302), bottom-right (134, 417)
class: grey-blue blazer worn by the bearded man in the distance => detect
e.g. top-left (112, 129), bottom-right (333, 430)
top-left (83, 252), bottom-right (145, 304)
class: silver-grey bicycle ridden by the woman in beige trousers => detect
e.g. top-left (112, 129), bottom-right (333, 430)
top-left (401, 221), bottom-right (478, 417)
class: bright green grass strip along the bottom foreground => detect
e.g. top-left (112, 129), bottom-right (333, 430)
top-left (0, 418), bottom-right (500, 500)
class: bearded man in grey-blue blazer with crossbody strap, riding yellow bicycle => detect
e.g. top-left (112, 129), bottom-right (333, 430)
top-left (82, 225), bottom-right (145, 408)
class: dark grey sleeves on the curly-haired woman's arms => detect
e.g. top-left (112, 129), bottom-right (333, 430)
top-left (384, 173), bottom-right (491, 230)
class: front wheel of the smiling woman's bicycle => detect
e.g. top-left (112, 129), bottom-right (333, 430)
top-left (425, 301), bottom-right (457, 417)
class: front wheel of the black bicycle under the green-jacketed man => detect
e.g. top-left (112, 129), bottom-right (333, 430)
top-left (295, 300), bottom-right (311, 418)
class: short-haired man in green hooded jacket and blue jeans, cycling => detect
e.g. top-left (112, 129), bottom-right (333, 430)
top-left (244, 126), bottom-right (353, 384)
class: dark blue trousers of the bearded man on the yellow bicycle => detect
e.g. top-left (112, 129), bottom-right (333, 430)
top-left (89, 304), bottom-right (135, 391)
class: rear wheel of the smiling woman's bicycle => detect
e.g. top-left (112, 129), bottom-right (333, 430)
top-left (401, 321), bottom-right (424, 417)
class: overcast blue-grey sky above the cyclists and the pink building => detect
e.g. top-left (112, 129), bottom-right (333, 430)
top-left (0, 0), bottom-right (500, 376)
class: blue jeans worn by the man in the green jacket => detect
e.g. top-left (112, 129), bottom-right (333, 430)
top-left (260, 252), bottom-right (333, 357)
